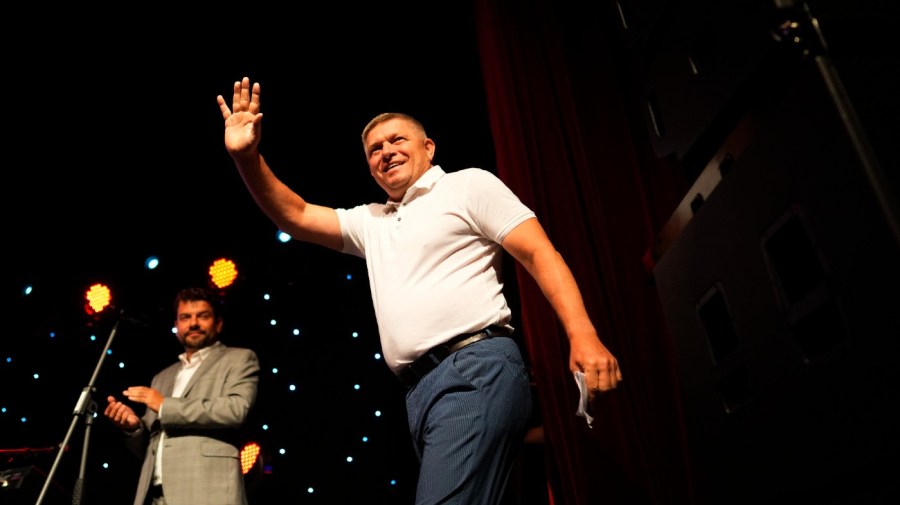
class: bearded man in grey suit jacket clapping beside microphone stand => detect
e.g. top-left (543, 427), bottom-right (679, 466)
top-left (104, 288), bottom-right (259, 505)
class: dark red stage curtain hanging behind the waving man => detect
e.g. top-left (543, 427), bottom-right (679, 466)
top-left (473, 0), bottom-right (692, 505)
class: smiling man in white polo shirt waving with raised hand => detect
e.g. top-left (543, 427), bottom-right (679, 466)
top-left (217, 77), bottom-right (622, 505)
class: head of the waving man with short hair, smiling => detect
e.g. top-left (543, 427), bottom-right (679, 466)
top-left (363, 116), bottom-right (434, 202)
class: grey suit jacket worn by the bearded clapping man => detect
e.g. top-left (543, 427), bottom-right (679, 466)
top-left (126, 345), bottom-right (259, 505)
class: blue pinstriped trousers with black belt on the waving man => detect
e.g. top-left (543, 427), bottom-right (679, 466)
top-left (406, 337), bottom-right (532, 505)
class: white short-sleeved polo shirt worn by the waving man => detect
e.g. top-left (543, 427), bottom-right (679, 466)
top-left (336, 165), bottom-right (535, 373)
